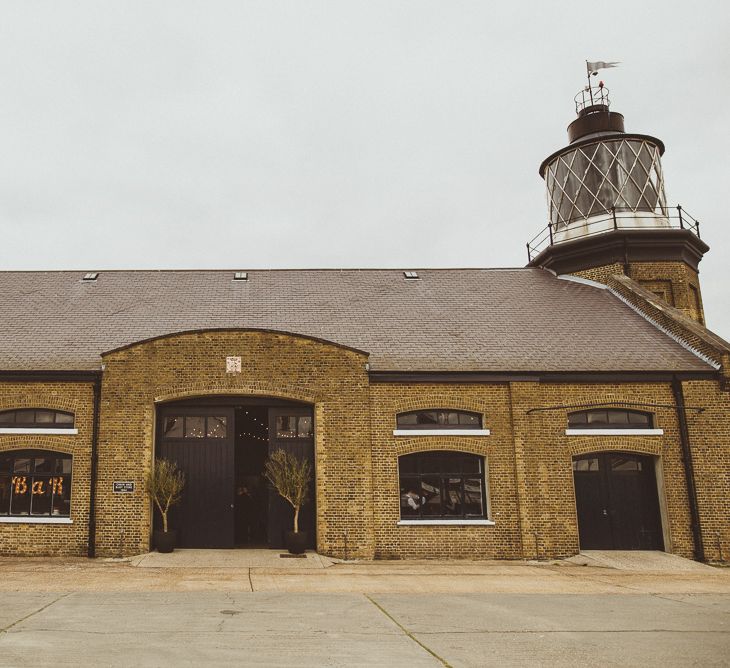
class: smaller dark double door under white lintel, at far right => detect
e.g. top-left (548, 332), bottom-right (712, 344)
top-left (573, 452), bottom-right (664, 550)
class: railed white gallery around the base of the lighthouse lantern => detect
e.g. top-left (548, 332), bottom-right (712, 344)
top-left (527, 205), bottom-right (700, 262)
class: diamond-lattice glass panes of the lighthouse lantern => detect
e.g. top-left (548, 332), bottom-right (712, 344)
top-left (545, 138), bottom-right (666, 233)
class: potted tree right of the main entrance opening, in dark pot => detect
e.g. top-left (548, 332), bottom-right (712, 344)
top-left (264, 450), bottom-right (312, 554)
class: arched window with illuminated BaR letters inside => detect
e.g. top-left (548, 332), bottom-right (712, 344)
top-left (0, 450), bottom-right (71, 520)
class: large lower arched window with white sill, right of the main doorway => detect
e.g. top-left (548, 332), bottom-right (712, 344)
top-left (398, 450), bottom-right (487, 520)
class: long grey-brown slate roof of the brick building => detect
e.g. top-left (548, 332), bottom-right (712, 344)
top-left (0, 268), bottom-right (711, 372)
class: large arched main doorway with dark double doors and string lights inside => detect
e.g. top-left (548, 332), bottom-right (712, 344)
top-left (155, 397), bottom-right (316, 548)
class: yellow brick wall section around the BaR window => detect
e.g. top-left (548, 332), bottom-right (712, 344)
top-left (0, 383), bottom-right (93, 556)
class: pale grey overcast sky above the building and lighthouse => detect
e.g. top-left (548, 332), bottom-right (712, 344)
top-left (0, 0), bottom-right (730, 338)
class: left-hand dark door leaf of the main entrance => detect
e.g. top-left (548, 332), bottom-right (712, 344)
top-left (155, 407), bottom-right (235, 548)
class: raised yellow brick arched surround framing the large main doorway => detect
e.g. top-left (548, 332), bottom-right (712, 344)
top-left (97, 331), bottom-right (373, 557)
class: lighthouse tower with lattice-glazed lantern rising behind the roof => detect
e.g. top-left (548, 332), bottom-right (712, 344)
top-left (527, 72), bottom-right (709, 324)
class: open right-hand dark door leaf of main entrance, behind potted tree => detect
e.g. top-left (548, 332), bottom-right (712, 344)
top-left (268, 406), bottom-right (317, 549)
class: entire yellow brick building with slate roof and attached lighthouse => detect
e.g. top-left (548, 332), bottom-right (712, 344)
top-left (0, 88), bottom-right (730, 561)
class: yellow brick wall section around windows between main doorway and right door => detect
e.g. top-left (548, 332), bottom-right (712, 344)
top-left (371, 383), bottom-right (521, 559)
